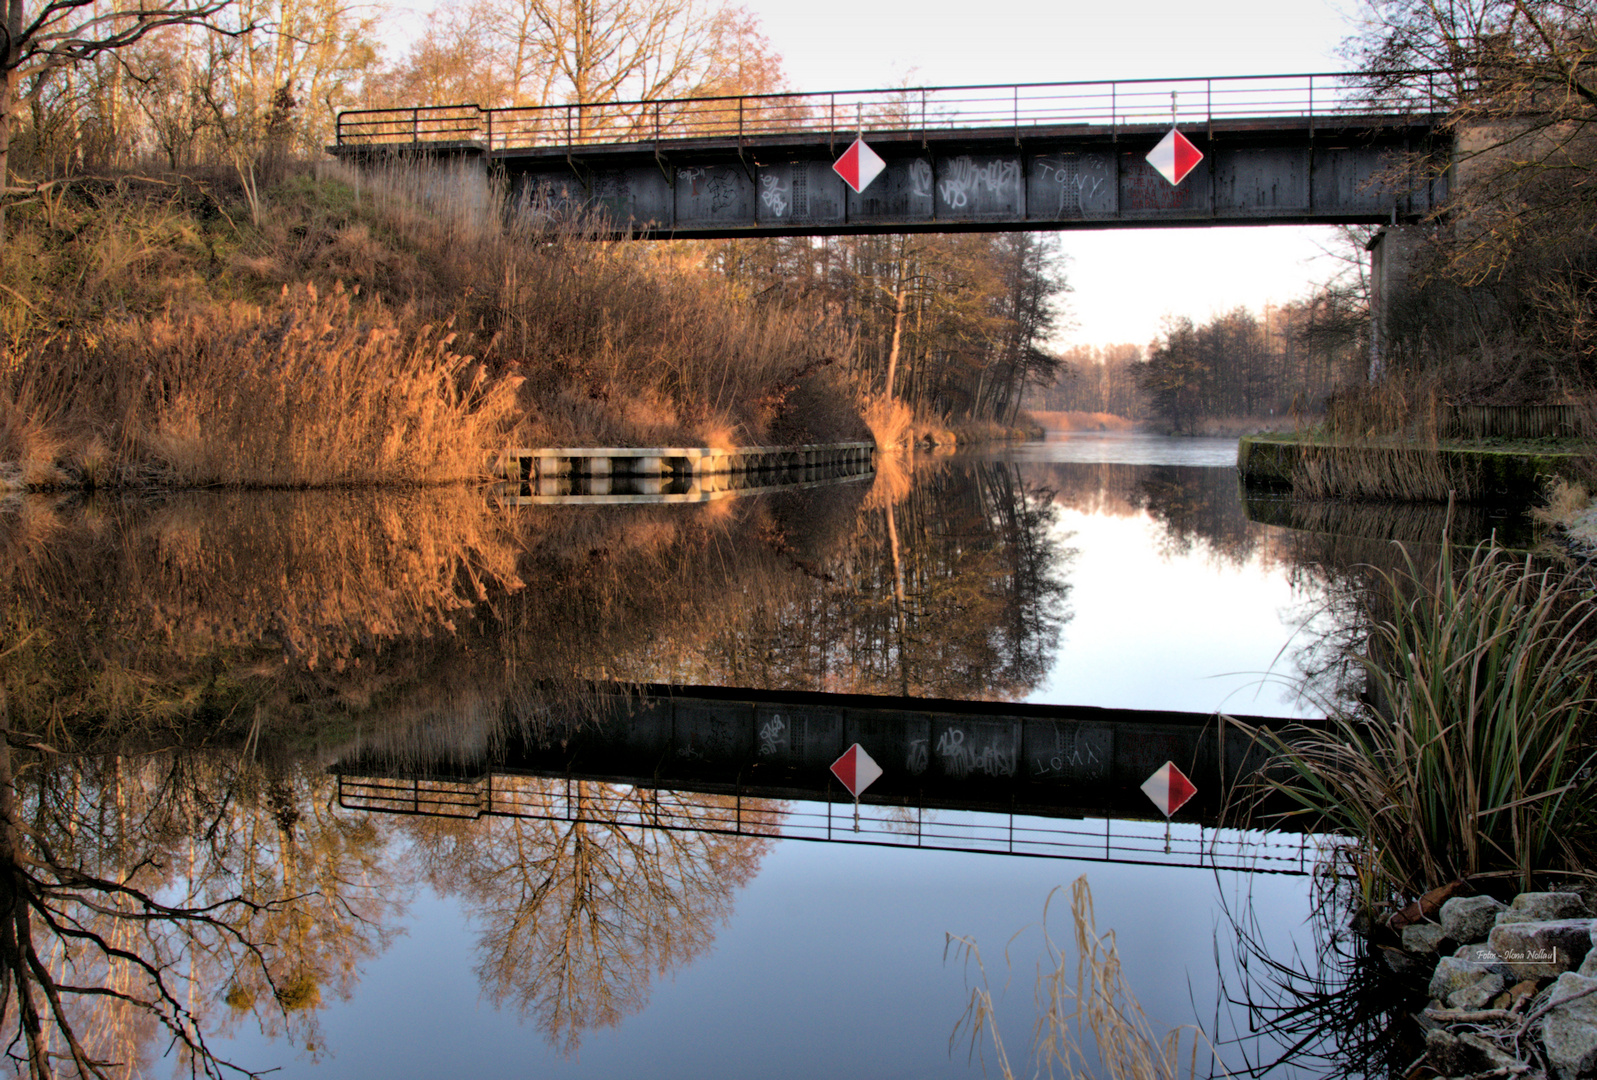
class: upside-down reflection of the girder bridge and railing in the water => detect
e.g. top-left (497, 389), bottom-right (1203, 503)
top-left (334, 687), bottom-right (1326, 874)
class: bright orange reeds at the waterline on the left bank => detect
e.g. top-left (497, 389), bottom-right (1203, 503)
top-left (0, 286), bottom-right (521, 487)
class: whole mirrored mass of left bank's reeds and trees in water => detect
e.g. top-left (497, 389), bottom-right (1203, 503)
top-left (0, 463), bottom-right (1098, 1077)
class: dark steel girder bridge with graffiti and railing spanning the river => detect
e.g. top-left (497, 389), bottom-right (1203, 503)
top-left (329, 72), bottom-right (1453, 238)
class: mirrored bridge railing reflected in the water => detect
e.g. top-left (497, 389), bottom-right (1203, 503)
top-left (339, 773), bottom-right (1329, 876)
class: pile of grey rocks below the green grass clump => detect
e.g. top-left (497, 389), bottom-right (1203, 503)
top-left (1402, 893), bottom-right (1597, 1080)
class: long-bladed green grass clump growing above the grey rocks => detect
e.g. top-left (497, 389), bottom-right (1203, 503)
top-left (1263, 534), bottom-right (1597, 898)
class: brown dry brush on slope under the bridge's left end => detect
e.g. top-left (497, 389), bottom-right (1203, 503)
top-left (323, 158), bottom-right (864, 446)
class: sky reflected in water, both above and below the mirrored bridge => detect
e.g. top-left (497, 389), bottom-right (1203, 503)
top-left (215, 435), bottom-right (1335, 1078)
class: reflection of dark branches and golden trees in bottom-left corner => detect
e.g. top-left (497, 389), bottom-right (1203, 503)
top-left (0, 732), bottom-right (402, 1077)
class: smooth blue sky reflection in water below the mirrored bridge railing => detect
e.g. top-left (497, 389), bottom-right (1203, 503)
top-left (227, 842), bottom-right (1308, 1078)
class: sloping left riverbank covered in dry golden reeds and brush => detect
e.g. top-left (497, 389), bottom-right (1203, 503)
top-left (0, 166), bottom-right (869, 489)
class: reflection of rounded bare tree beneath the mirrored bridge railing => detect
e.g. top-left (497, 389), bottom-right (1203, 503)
top-left (397, 776), bottom-right (783, 1054)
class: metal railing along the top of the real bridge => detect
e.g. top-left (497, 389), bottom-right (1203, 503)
top-left (337, 72), bottom-right (1448, 152)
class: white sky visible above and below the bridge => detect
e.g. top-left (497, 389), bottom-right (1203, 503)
top-left (744, 0), bottom-right (1356, 345)
